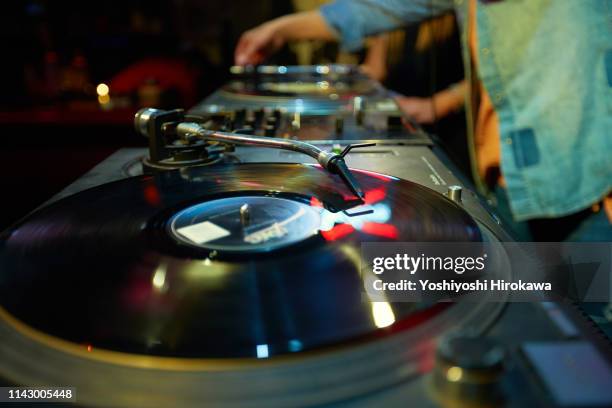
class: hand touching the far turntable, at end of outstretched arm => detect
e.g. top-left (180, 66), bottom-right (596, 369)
top-left (234, 20), bottom-right (285, 65)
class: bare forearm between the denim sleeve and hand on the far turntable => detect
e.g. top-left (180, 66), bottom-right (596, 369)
top-left (266, 10), bottom-right (338, 41)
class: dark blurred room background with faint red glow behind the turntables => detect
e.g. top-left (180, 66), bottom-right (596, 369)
top-left (0, 0), bottom-right (462, 230)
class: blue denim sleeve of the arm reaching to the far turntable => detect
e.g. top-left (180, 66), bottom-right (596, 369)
top-left (320, 0), bottom-right (453, 51)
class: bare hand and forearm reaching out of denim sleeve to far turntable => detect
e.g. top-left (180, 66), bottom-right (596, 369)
top-left (234, 10), bottom-right (338, 65)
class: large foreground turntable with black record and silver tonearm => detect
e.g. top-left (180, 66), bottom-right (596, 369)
top-left (0, 68), bottom-right (612, 407)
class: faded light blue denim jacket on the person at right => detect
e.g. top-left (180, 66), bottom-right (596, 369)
top-left (321, 0), bottom-right (612, 220)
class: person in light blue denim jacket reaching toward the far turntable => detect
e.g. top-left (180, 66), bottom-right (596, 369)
top-left (235, 0), bottom-right (612, 241)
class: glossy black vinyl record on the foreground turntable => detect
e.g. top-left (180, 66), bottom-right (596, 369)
top-left (0, 164), bottom-right (481, 358)
